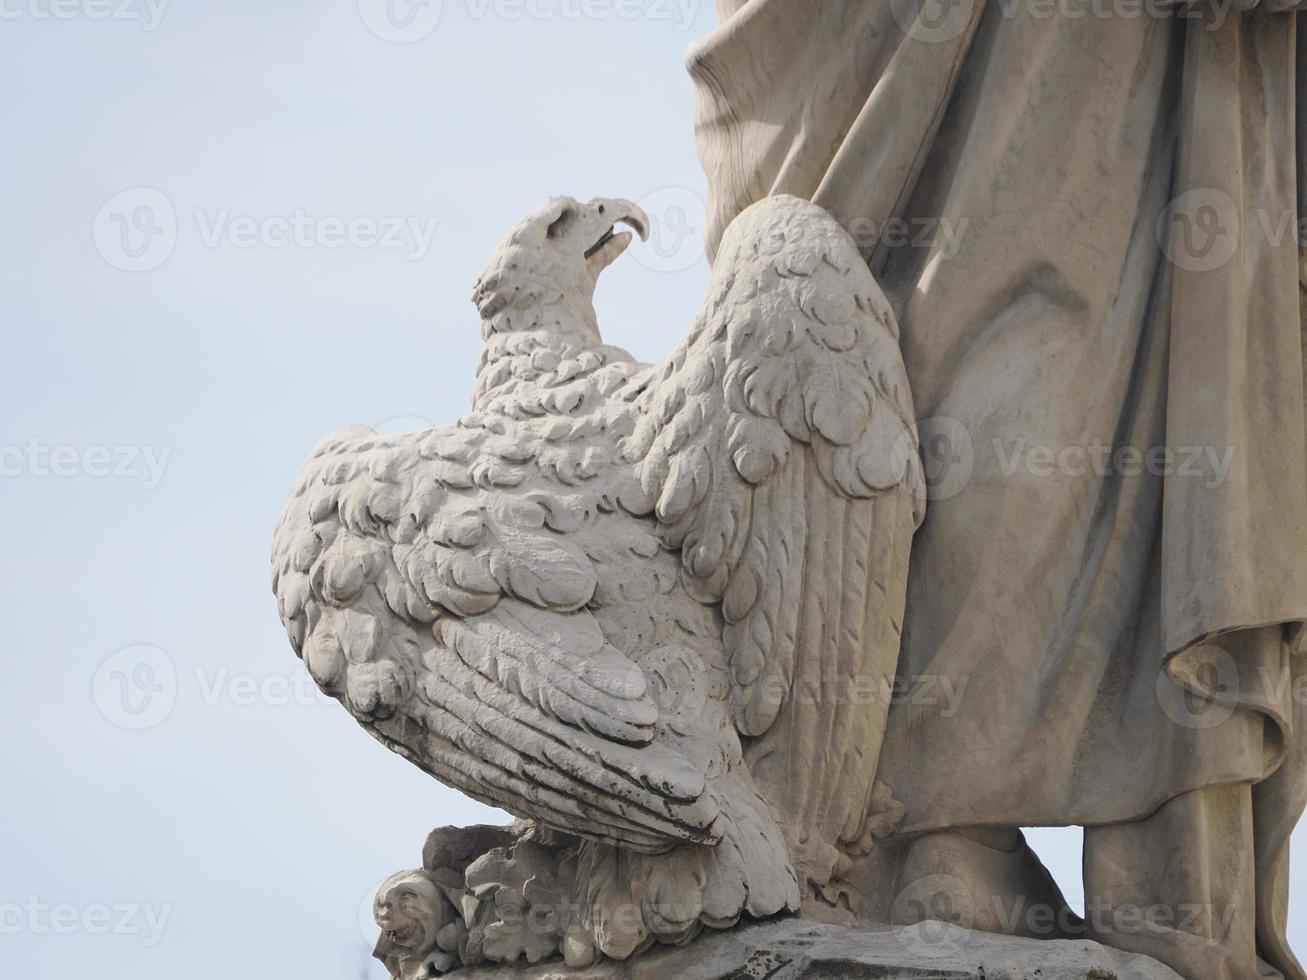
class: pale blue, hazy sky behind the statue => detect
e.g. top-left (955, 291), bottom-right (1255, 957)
top-left (0, 0), bottom-right (1307, 980)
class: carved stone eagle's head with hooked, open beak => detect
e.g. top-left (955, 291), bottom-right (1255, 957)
top-left (472, 197), bottom-right (650, 340)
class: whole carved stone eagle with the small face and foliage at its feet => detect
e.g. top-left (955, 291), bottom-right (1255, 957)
top-left (272, 196), bottom-right (925, 979)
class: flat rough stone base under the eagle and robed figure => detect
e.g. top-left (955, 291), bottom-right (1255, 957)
top-left (450, 919), bottom-right (1180, 980)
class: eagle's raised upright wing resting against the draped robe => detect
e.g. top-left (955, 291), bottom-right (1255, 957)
top-left (623, 196), bottom-right (925, 877)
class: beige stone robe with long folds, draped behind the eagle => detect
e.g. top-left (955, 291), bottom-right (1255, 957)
top-left (689, 0), bottom-right (1307, 972)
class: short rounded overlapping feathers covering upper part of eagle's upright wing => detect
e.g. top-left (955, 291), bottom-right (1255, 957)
top-left (625, 197), bottom-right (925, 736)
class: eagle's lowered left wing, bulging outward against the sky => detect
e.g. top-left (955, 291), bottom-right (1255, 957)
top-left (273, 425), bottom-right (720, 852)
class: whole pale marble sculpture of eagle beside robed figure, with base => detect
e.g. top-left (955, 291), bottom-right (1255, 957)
top-left (273, 0), bottom-right (1307, 980)
